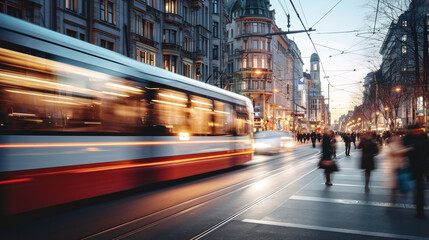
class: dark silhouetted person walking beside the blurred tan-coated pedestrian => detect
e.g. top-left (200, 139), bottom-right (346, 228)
top-left (358, 135), bottom-right (379, 192)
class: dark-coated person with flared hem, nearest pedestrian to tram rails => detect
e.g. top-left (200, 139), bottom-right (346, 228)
top-left (319, 130), bottom-right (338, 186)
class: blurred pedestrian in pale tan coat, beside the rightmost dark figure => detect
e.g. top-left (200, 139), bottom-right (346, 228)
top-left (387, 133), bottom-right (410, 204)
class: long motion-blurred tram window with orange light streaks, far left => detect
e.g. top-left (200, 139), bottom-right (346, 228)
top-left (0, 45), bottom-right (145, 134)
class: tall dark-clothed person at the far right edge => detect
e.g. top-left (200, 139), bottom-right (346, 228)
top-left (404, 125), bottom-right (429, 218)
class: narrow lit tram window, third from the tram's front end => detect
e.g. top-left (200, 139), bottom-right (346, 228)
top-left (190, 96), bottom-right (213, 135)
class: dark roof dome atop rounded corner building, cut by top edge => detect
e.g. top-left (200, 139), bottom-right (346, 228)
top-left (229, 0), bottom-right (272, 18)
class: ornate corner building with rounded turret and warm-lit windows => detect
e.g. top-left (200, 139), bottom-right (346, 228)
top-left (226, 0), bottom-right (294, 130)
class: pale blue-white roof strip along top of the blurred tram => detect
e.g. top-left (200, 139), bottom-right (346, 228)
top-left (0, 13), bottom-right (251, 110)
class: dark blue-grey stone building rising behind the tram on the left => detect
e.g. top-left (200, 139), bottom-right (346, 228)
top-left (0, 0), bottom-right (225, 87)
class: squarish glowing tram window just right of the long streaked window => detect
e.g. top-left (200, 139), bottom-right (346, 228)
top-left (151, 89), bottom-right (189, 135)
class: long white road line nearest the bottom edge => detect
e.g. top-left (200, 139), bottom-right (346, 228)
top-left (242, 219), bottom-right (427, 240)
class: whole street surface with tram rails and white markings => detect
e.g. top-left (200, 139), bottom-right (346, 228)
top-left (0, 139), bottom-right (429, 239)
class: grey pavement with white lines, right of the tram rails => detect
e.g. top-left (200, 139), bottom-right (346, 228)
top-left (224, 142), bottom-right (429, 240)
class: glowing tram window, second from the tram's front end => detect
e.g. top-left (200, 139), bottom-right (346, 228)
top-left (214, 101), bottom-right (233, 135)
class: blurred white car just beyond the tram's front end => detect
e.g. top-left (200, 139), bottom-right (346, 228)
top-left (253, 131), bottom-right (295, 154)
